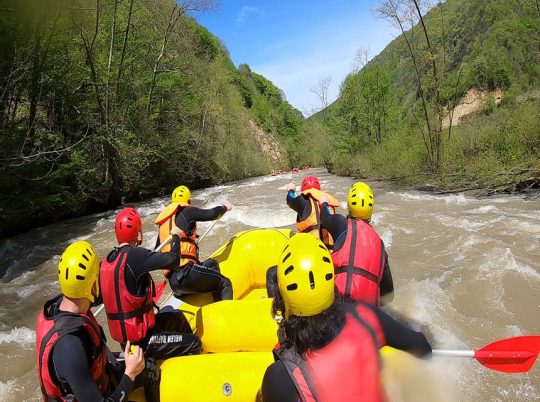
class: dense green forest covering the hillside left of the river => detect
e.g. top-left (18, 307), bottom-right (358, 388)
top-left (0, 0), bottom-right (303, 237)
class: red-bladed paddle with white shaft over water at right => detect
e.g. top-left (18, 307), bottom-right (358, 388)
top-left (433, 335), bottom-right (540, 373)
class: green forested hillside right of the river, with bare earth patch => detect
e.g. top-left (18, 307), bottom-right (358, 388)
top-left (306, 0), bottom-right (540, 193)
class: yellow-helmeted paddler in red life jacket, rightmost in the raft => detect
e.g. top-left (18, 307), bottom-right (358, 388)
top-left (320, 182), bottom-right (394, 306)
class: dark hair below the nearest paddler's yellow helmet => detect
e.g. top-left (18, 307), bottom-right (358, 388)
top-left (272, 291), bottom-right (345, 355)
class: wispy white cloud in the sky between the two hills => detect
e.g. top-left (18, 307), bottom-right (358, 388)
top-left (251, 15), bottom-right (395, 116)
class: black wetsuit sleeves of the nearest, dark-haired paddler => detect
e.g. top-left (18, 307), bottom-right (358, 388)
top-left (261, 305), bottom-right (431, 402)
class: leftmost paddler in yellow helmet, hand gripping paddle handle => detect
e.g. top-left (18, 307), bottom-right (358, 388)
top-left (36, 241), bottom-right (145, 402)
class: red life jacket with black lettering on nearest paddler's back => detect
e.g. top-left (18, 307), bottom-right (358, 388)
top-left (274, 304), bottom-right (386, 402)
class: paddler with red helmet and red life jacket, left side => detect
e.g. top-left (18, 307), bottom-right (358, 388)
top-left (99, 207), bottom-right (201, 360)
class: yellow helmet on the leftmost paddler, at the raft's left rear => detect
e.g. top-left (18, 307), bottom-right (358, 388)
top-left (58, 241), bottom-right (99, 302)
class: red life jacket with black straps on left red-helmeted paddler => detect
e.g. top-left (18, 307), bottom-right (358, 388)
top-left (99, 251), bottom-right (156, 344)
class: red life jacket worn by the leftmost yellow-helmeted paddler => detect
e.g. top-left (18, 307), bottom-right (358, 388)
top-left (36, 295), bottom-right (109, 401)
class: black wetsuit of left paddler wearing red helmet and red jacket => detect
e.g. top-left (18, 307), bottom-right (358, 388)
top-left (103, 235), bottom-right (201, 360)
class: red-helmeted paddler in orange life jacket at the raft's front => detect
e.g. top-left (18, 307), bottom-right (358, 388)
top-left (287, 176), bottom-right (339, 251)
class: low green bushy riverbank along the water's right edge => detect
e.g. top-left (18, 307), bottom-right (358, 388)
top-left (332, 98), bottom-right (540, 196)
